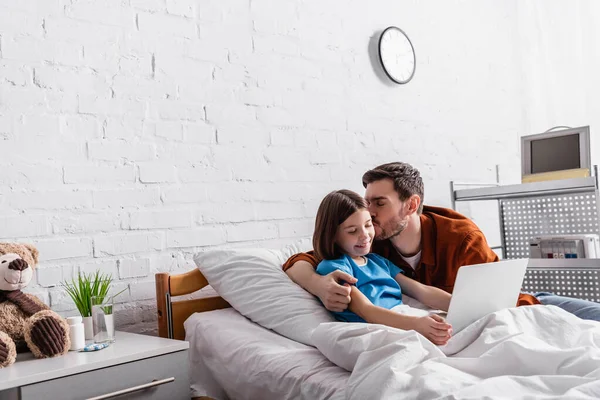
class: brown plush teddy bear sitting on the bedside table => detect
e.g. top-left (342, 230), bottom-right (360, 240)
top-left (0, 243), bottom-right (71, 368)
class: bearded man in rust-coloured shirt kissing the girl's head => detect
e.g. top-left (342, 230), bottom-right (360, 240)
top-left (283, 162), bottom-right (600, 321)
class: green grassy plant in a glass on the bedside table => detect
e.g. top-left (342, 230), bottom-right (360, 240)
top-left (63, 271), bottom-right (126, 340)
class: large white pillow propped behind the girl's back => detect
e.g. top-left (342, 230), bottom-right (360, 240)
top-left (194, 242), bottom-right (334, 346)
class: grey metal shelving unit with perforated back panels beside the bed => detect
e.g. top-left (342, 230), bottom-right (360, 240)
top-left (450, 173), bottom-right (600, 302)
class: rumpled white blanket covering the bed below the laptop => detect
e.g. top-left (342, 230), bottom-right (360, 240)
top-left (313, 306), bottom-right (600, 399)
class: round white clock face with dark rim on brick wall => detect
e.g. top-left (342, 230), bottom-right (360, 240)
top-left (379, 26), bottom-right (416, 83)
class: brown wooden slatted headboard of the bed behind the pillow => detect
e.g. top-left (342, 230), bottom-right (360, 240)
top-left (155, 269), bottom-right (231, 340)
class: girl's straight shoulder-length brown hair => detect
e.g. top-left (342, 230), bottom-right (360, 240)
top-left (313, 189), bottom-right (368, 260)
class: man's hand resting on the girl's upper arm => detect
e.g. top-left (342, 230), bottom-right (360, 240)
top-left (312, 270), bottom-right (357, 312)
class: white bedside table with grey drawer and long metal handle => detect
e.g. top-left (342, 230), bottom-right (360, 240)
top-left (0, 332), bottom-right (190, 400)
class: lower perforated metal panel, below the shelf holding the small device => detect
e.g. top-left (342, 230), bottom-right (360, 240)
top-left (522, 267), bottom-right (600, 303)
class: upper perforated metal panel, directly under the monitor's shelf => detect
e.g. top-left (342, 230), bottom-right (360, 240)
top-left (500, 192), bottom-right (600, 258)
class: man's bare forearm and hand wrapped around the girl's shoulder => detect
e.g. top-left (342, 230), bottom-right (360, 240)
top-left (285, 260), bottom-right (356, 312)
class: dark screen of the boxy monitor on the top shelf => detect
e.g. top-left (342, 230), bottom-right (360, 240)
top-left (531, 134), bottom-right (581, 174)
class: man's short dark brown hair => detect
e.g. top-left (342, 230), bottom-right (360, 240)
top-left (363, 162), bottom-right (425, 214)
